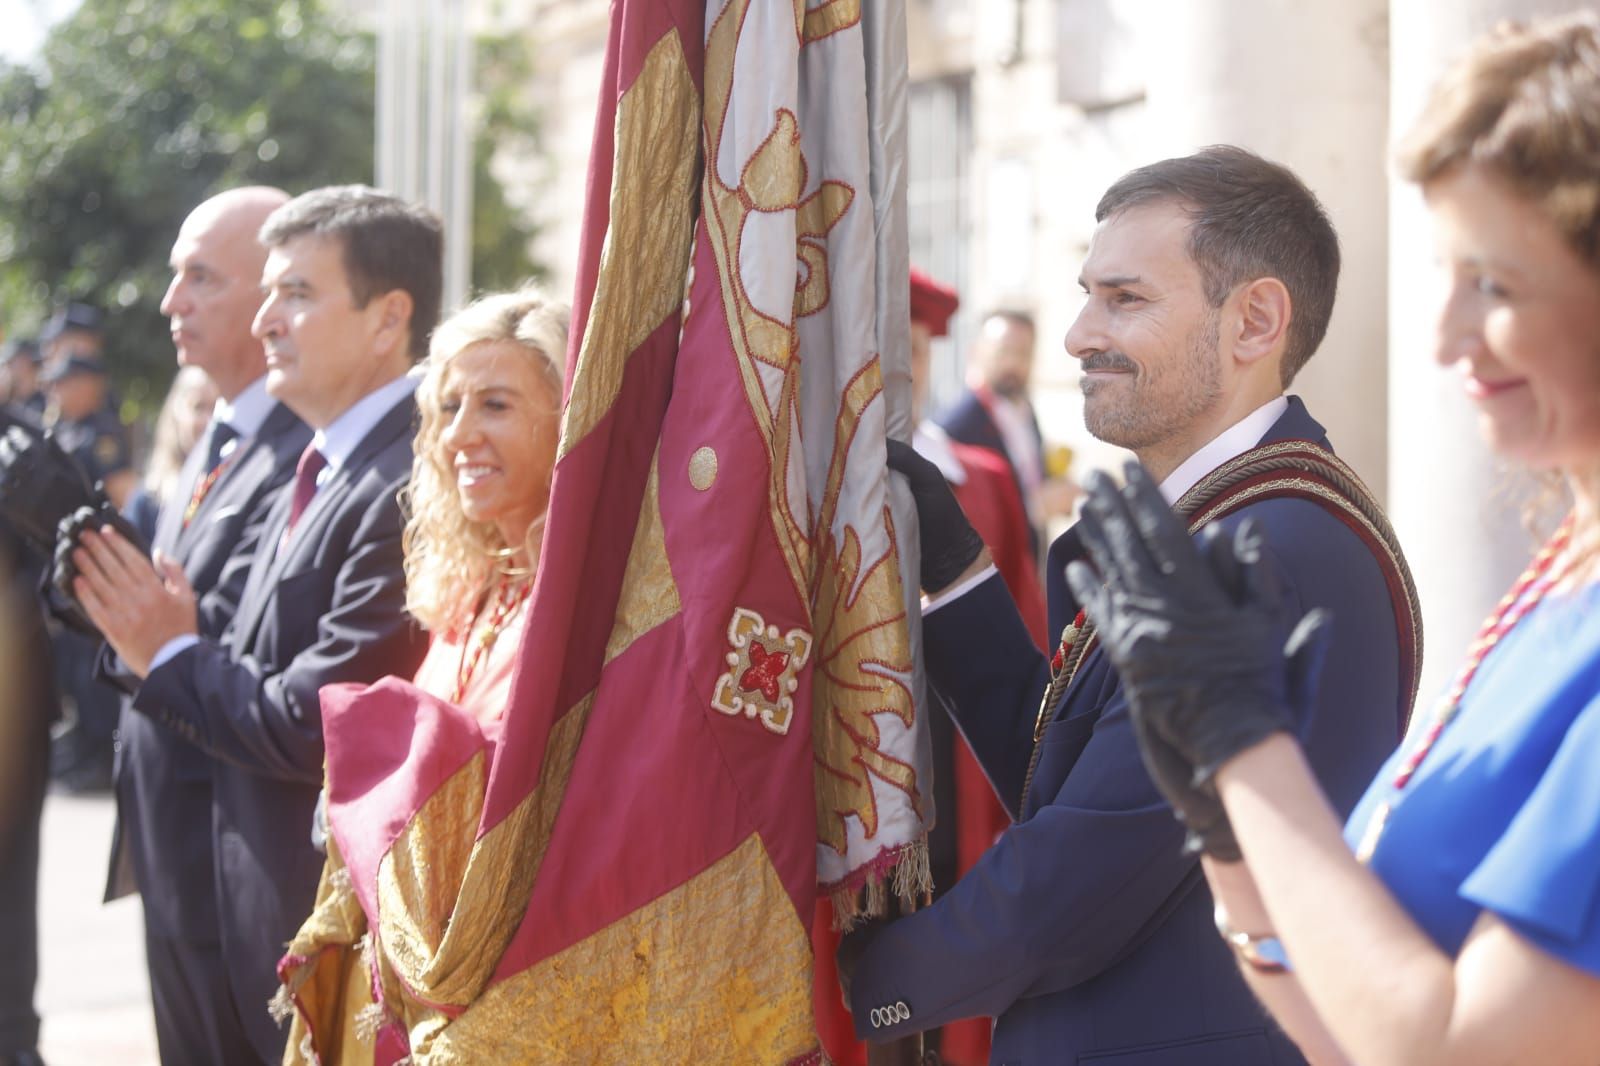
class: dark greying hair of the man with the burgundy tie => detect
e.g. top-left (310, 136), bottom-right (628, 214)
top-left (261, 186), bottom-right (445, 360)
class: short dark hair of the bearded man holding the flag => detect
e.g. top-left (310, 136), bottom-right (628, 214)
top-left (1094, 144), bottom-right (1339, 387)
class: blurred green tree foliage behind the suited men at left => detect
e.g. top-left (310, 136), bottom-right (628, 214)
top-left (0, 0), bottom-right (533, 408)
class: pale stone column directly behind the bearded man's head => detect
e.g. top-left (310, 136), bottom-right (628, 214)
top-left (1141, 0), bottom-right (1389, 499)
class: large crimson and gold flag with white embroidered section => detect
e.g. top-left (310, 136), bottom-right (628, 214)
top-left (283, 0), bottom-right (931, 1064)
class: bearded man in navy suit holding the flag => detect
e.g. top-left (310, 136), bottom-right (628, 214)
top-left (842, 147), bottom-right (1414, 1066)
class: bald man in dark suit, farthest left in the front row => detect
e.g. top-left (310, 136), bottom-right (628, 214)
top-left (90, 187), bottom-right (310, 1063)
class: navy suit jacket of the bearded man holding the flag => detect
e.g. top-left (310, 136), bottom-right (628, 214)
top-left (851, 399), bottom-right (1408, 1066)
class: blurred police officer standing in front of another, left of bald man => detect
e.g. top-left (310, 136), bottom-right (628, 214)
top-left (43, 347), bottom-right (139, 792)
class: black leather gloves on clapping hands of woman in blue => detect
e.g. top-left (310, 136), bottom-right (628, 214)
top-left (1067, 464), bottom-right (1326, 861)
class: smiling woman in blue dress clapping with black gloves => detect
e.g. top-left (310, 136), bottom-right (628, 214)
top-left (1069, 11), bottom-right (1600, 1066)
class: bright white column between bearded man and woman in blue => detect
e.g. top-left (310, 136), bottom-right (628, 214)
top-left (1389, 0), bottom-right (1573, 717)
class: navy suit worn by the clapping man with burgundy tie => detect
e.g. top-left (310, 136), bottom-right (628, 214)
top-left (133, 399), bottom-right (426, 1061)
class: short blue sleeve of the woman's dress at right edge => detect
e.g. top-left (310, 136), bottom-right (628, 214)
top-left (1461, 687), bottom-right (1600, 975)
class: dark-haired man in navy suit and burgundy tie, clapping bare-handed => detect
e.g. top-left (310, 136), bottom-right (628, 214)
top-left (74, 186), bottom-right (443, 1063)
